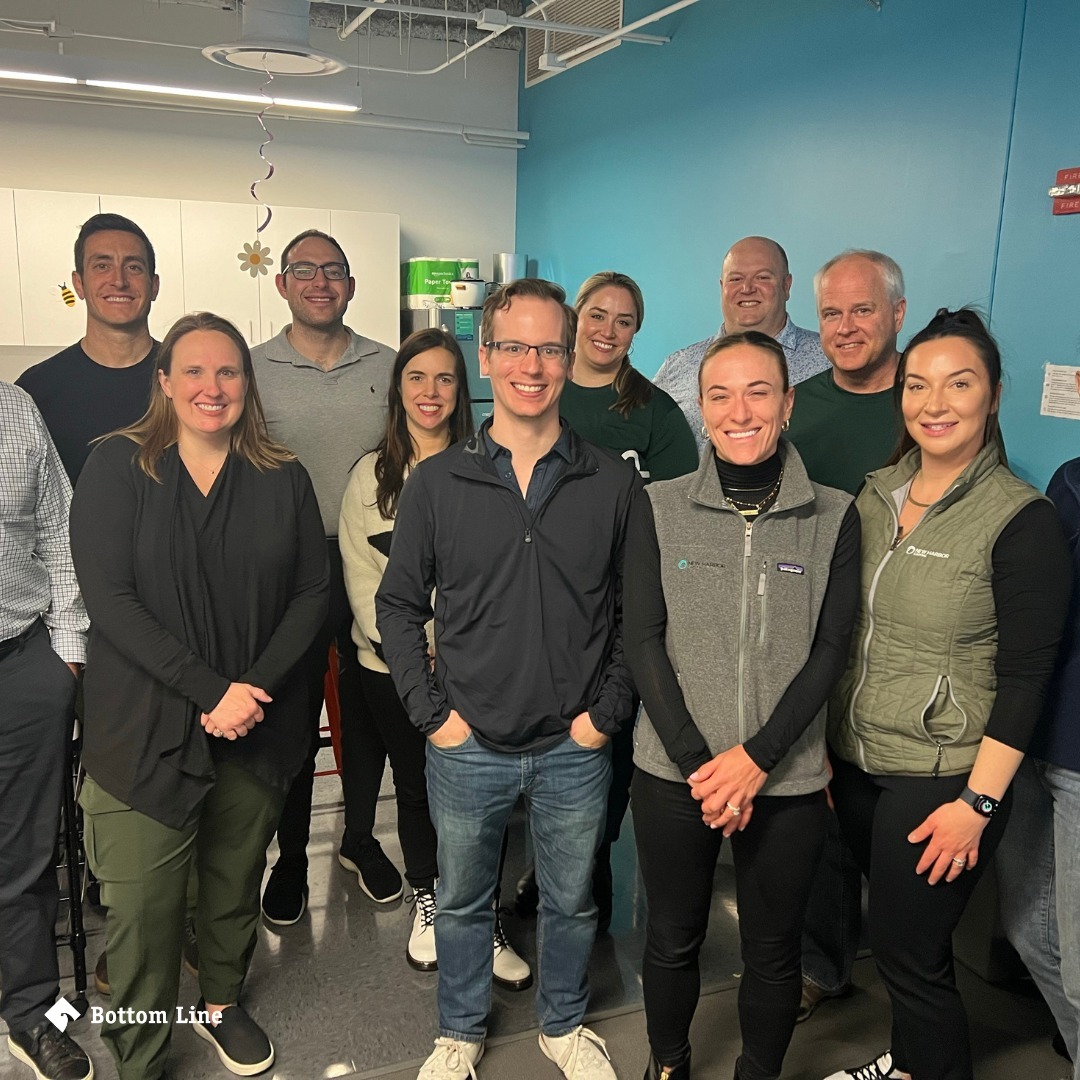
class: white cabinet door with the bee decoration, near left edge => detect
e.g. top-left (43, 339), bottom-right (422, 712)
top-left (14, 188), bottom-right (98, 348)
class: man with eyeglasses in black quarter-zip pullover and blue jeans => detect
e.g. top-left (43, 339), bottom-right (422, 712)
top-left (375, 278), bottom-right (640, 1080)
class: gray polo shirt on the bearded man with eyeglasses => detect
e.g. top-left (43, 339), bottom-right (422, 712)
top-left (252, 326), bottom-right (396, 537)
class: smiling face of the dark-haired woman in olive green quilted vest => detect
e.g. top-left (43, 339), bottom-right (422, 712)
top-left (902, 337), bottom-right (1001, 471)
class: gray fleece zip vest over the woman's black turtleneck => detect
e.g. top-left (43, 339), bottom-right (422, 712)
top-left (634, 442), bottom-right (851, 795)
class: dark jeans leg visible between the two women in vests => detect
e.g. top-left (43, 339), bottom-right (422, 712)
top-left (802, 813), bottom-right (863, 994)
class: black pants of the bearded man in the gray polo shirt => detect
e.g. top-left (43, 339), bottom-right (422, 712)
top-left (278, 537), bottom-right (387, 860)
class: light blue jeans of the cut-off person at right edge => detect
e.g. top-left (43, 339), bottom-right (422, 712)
top-left (997, 758), bottom-right (1080, 1080)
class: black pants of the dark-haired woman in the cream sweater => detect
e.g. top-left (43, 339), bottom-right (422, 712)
top-left (356, 666), bottom-right (438, 889)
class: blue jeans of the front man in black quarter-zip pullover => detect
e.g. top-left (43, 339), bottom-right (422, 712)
top-left (427, 734), bottom-right (611, 1042)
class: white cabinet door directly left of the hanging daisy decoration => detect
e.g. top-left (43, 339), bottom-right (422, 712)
top-left (180, 200), bottom-right (262, 345)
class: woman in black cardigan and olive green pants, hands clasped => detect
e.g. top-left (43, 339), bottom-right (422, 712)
top-left (71, 313), bottom-right (327, 1080)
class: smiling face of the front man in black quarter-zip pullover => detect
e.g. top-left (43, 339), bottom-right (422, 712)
top-left (480, 296), bottom-right (573, 422)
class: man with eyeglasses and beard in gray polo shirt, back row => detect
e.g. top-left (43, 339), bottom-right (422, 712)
top-left (252, 229), bottom-right (399, 924)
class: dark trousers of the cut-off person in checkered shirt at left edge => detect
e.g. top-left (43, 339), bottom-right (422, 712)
top-left (0, 622), bottom-right (76, 1031)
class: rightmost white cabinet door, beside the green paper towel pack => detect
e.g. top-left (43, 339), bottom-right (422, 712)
top-left (330, 210), bottom-right (401, 349)
